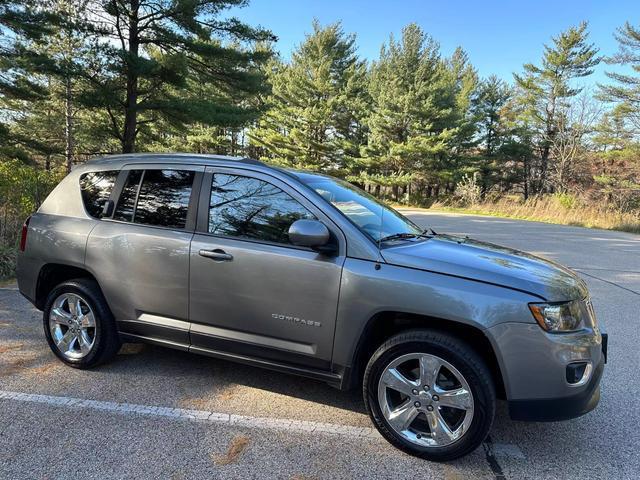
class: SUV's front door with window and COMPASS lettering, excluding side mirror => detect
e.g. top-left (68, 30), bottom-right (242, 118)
top-left (189, 168), bottom-right (345, 369)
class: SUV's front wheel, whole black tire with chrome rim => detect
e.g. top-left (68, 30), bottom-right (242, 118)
top-left (363, 330), bottom-right (496, 462)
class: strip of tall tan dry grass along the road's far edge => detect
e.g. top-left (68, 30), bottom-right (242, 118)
top-left (431, 197), bottom-right (640, 233)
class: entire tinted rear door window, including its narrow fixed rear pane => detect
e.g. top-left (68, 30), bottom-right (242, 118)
top-left (113, 170), bottom-right (195, 229)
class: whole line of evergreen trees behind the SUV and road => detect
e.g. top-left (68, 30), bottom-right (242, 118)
top-left (0, 0), bottom-right (640, 210)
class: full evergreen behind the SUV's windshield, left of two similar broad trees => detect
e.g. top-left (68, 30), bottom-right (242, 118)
top-left (250, 21), bottom-right (367, 171)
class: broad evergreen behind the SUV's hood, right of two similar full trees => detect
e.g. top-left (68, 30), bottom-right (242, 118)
top-left (363, 24), bottom-right (468, 198)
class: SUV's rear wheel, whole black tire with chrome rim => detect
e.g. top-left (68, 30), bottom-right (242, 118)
top-left (42, 278), bottom-right (122, 369)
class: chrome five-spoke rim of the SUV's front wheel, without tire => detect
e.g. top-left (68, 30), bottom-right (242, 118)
top-left (378, 353), bottom-right (473, 447)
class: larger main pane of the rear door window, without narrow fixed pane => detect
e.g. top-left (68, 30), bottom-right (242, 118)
top-left (133, 170), bottom-right (195, 228)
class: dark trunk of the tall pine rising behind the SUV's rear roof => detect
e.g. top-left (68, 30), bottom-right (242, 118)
top-left (122, 0), bottom-right (140, 153)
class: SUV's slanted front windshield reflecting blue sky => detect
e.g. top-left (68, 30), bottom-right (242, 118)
top-left (298, 174), bottom-right (422, 242)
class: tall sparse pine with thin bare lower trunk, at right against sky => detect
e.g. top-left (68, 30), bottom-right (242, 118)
top-left (514, 22), bottom-right (600, 193)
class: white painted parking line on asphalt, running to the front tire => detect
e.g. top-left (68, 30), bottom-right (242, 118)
top-left (0, 390), bottom-right (382, 439)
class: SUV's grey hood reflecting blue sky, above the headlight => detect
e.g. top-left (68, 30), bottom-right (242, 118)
top-left (381, 235), bottom-right (588, 302)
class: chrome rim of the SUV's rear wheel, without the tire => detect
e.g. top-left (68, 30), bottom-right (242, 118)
top-left (49, 293), bottom-right (96, 360)
